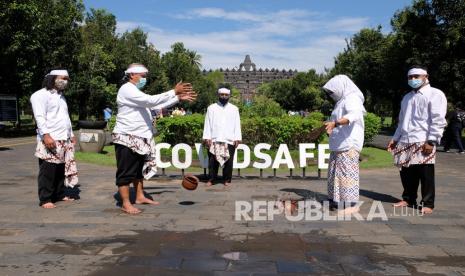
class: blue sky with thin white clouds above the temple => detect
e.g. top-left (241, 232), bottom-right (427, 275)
top-left (84, 0), bottom-right (412, 72)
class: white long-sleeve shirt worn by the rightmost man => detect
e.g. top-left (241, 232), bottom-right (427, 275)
top-left (392, 84), bottom-right (447, 143)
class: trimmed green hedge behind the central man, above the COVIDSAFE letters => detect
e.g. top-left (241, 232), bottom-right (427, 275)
top-left (157, 113), bottom-right (323, 148)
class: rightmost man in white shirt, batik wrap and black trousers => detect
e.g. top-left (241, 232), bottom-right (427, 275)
top-left (388, 66), bottom-right (447, 214)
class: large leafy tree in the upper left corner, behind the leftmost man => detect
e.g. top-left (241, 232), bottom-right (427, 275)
top-left (0, 0), bottom-right (84, 125)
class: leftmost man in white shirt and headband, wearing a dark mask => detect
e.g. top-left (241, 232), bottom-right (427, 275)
top-left (31, 70), bottom-right (78, 209)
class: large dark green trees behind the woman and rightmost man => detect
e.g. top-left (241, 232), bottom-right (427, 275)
top-left (330, 0), bottom-right (465, 124)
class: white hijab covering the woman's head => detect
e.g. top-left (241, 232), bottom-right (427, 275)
top-left (323, 75), bottom-right (366, 113)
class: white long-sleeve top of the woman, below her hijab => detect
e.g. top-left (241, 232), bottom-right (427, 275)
top-left (329, 93), bottom-right (365, 151)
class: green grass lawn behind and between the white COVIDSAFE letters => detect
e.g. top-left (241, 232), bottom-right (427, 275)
top-left (75, 146), bottom-right (393, 170)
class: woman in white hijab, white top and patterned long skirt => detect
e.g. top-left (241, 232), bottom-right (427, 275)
top-left (323, 75), bottom-right (366, 214)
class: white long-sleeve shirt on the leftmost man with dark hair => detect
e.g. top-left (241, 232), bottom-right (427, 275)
top-left (30, 88), bottom-right (74, 140)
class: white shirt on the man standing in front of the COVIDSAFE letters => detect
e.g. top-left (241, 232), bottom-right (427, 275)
top-left (202, 103), bottom-right (242, 145)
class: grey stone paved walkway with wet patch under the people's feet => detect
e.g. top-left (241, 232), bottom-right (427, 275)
top-left (0, 140), bottom-right (465, 275)
